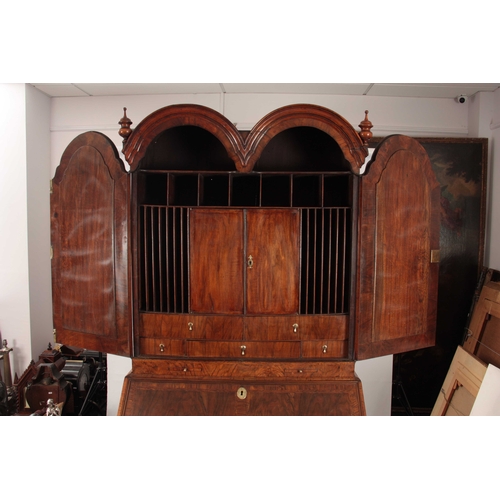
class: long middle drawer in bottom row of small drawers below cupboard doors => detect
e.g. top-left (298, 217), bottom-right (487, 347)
top-left (186, 340), bottom-right (300, 359)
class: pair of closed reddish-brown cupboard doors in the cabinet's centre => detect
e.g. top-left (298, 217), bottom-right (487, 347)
top-left (189, 208), bottom-right (300, 314)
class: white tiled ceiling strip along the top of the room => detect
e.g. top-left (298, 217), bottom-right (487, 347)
top-left (31, 83), bottom-right (500, 99)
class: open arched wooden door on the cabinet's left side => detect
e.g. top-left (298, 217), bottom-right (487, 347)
top-left (51, 132), bottom-right (132, 356)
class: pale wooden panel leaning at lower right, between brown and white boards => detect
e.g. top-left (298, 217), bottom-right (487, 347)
top-left (431, 346), bottom-right (487, 416)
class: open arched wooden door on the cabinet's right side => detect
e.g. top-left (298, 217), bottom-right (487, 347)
top-left (356, 135), bottom-right (440, 359)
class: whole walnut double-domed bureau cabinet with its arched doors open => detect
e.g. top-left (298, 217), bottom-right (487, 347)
top-left (51, 104), bottom-right (439, 415)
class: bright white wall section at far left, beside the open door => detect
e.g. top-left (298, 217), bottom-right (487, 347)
top-left (0, 84), bottom-right (52, 376)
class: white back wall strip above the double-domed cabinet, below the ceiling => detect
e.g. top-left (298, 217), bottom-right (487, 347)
top-left (51, 94), bottom-right (468, 175)
